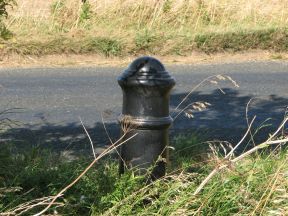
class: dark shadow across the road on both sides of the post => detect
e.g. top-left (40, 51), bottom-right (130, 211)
top-left (1, 88), bottom-right (288, 157)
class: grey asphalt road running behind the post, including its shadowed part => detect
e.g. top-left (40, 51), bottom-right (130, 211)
top-left (0, 61), bottom-right (288, 152)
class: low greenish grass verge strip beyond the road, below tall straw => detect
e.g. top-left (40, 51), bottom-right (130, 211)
top-left (1, 28), bottom-right (288, 57)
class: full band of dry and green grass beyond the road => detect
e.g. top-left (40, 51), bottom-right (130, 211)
top-left (3, 0), bottom-right (288, 55)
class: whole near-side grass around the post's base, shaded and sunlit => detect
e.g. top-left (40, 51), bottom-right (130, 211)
top-left (0, 135), bottom-right (288, 215)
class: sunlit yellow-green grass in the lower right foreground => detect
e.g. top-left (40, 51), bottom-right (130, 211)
top-left (105, 151), bottom-right (288, 215)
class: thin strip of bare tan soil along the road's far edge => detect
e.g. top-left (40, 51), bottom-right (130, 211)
top-left (0, 50), bottom-right (288, 68)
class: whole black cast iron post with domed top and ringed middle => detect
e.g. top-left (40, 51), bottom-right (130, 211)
top-left (118, 57), bottom-right (175, 180)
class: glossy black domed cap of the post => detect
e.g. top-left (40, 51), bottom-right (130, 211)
top-left (118, 56), bottom-right (175, 86)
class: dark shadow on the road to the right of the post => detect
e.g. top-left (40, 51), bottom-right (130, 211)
top-left (171, 88), bottom-right (288, 143)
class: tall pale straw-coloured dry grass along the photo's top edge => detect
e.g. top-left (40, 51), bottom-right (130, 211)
top-left (13, 0), bottom-right (288, 25)
